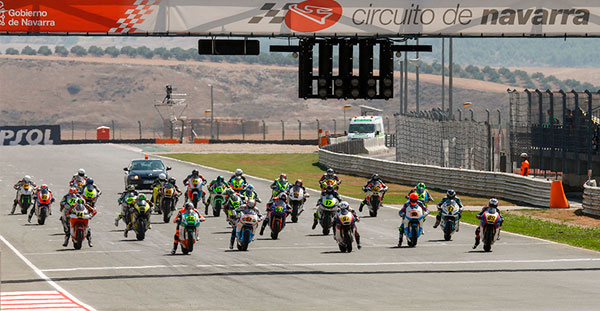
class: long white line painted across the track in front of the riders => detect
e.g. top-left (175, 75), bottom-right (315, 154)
top-left (42, 258), bottom-right (600, 272)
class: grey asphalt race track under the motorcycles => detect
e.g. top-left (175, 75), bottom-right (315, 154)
top-left (0, 145), bottom-right (600, 310)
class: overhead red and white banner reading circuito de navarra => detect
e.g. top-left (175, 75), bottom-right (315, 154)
top-left (0, 0), bottom-right (600, 36)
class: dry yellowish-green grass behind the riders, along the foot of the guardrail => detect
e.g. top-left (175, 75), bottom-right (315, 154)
top-left (163, 153), bottom-right (513, 206)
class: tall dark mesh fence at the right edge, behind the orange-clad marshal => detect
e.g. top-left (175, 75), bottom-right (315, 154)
top-left (509, 90), bottom-right (600, 176)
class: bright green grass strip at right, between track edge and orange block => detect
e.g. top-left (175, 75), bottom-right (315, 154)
top-left (454, 211), bottom-right (600, 251)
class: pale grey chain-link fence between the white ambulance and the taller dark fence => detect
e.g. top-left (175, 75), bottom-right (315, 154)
top-left (396, 115), bottom-right (492, 170)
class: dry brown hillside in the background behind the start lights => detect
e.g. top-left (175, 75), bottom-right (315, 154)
top-left (0, 55), bottom-right (508, 129)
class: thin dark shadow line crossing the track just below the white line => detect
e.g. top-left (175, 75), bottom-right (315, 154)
top-left (2, 266), bottom-right (600, 284)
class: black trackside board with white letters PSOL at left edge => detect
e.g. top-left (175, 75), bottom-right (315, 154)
top-left (0, 125), bottom-right (60, 146)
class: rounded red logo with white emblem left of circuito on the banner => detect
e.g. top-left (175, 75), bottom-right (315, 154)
top-left (285, 0), bottom-right (342, 32)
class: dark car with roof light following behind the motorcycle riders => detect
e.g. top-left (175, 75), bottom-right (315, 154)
top-left (123, 159), bottom-right (171, 190)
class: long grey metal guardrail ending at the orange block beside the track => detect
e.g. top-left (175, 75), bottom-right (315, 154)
top-left (319, 149), bottom-right (552, 207)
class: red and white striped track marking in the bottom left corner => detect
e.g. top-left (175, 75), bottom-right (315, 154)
top-left (0, 291), bottom-right (90, 311)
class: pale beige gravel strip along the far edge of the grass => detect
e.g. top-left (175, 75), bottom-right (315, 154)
top-left (136, 144), bottom-right (319, 153)
